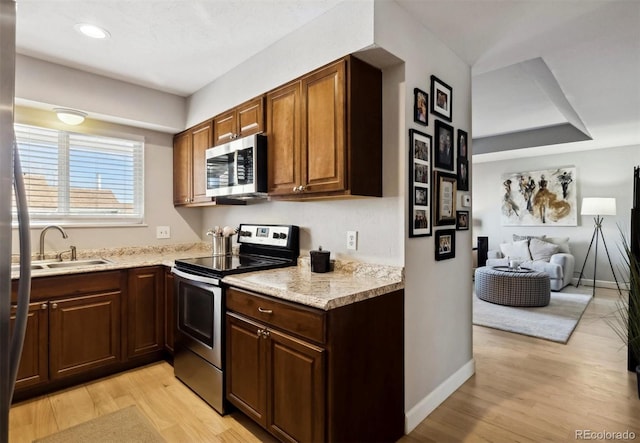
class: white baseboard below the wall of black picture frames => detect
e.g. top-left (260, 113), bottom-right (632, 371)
top-left (404, 358), bottom-right (476, 434)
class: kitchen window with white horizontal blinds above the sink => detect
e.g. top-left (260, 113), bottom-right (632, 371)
top-left (13, 124), bottom-right (144, 224)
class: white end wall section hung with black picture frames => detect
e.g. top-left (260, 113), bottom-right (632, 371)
top-left (375, 2), bottom-right (473, 430)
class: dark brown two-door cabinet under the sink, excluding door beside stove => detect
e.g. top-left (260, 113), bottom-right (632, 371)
top-left (12, 271), bottom-right (126, 400)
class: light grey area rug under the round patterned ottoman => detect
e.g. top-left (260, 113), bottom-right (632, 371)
top-left (473, 288), bottom-right (591, 344)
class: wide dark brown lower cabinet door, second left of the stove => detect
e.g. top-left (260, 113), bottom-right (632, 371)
top-left (49, 291), bottom-right (122, 380)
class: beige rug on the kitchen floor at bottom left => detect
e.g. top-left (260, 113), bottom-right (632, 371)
top-left (35, 406), bottom-right (165, 443)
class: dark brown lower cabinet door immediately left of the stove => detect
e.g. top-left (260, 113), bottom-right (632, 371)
top-left (127, 267), bottom-right (164, 358)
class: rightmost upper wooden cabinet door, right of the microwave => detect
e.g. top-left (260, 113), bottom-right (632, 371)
top-left (301, 60), bottom-right (347, 193)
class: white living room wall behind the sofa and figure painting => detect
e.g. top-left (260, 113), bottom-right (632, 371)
top-left (472, 146), bottom-right (640, 284)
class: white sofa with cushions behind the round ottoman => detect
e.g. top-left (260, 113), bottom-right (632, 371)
top-left (487, 234), bottom-right (576, 291)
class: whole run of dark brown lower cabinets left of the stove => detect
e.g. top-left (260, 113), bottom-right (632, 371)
top-left (12, 266), bottom-right (173, 400)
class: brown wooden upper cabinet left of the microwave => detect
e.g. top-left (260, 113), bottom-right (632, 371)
top-left (173, 120), bottom-right (213, 206)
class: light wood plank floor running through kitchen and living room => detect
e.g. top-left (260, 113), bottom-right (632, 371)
top-left (9, 289), bottom-right (640, 443)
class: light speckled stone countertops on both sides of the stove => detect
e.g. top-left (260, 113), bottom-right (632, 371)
top-left (11, 243), bottom-right (404, 310)
